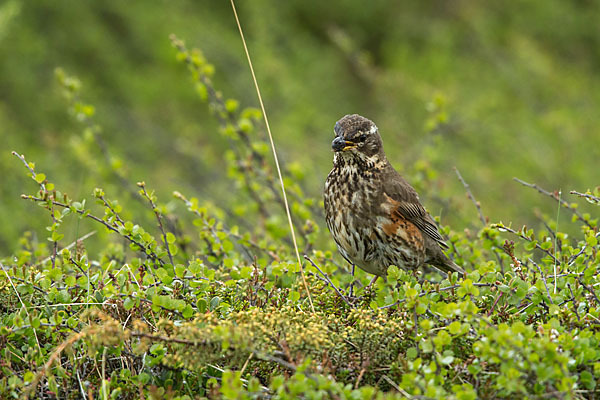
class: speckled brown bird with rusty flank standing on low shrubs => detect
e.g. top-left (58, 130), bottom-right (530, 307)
top-left (323, 114), bottom-right (465, 286)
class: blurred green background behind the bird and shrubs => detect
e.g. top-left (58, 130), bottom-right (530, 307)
top-left (0, 0), bottom-right (600, 255)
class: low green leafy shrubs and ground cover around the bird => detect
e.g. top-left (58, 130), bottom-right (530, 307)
top-left (0, 23), bottom-right (600, 399)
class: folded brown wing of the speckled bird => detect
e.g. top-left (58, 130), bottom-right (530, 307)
top-left (383, 168), bottom-right (448, 248)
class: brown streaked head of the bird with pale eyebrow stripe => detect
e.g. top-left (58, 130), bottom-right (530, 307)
top-left (331, 114), bottom-right (385, 161)
